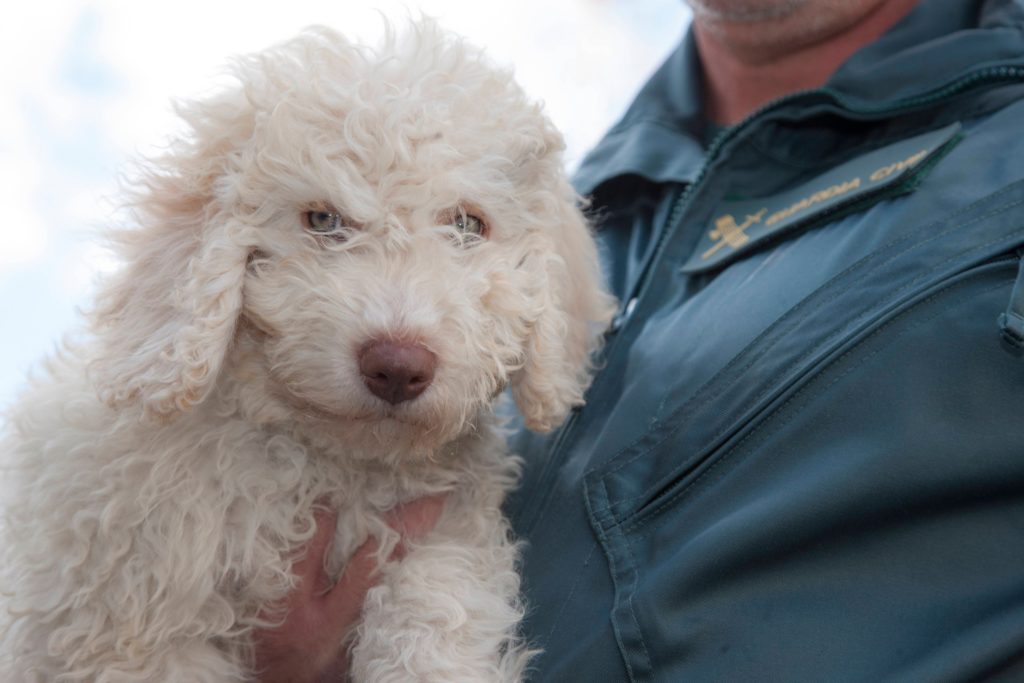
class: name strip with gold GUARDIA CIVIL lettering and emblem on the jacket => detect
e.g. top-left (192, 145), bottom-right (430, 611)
top-left (683, 123), bottom-right (961, 272)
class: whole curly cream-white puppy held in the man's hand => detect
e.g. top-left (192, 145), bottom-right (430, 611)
top-left (0, 23), bottom-right (611, 683)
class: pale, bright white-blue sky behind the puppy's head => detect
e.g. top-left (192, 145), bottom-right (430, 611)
top-left (0, 0), bottom-right (689, 410)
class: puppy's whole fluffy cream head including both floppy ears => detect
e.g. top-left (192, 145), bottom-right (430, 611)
top-left (88, 24), bottom-right (612, 452)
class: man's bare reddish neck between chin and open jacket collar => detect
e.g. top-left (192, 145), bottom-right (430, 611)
top-left (694, 0), bottom-right (916, 125)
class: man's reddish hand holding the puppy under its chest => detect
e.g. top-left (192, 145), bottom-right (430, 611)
top-left (255, 496), bottom-right (444, 683)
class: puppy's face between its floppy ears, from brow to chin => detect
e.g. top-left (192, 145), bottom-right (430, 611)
top-left (243, 139), bottom-right (552, 451)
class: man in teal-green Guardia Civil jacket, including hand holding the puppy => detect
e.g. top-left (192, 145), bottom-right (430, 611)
top-left (259, 0), bottom-right (1024, 681)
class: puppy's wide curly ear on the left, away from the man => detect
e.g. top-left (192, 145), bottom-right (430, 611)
top-left (89, 92), bottom-right (253, 419)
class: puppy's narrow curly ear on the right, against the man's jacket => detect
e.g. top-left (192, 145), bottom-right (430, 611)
top-left (511, 167), bottom-right (615, 431)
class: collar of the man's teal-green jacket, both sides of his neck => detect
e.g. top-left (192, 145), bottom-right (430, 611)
top-left (574, 0), bottom-right (1024, 195)
